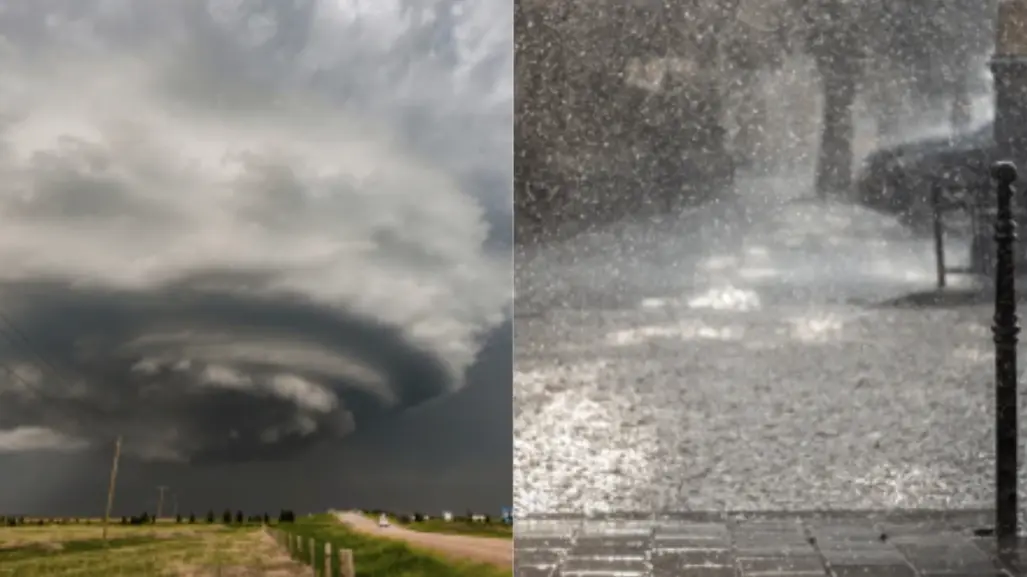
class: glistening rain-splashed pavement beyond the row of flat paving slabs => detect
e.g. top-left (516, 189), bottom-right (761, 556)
top-left (514, 174), bottom-right (1027, 514)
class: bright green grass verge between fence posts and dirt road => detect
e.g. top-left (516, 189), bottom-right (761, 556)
top-left (281, 513), bottom-right (512, 577)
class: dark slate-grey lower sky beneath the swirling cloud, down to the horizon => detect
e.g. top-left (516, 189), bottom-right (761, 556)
top-left (0, 320), bottom-right (512, 516)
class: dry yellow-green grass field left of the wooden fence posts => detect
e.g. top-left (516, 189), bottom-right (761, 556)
top-left (0, 523), bottom-right (310, 577)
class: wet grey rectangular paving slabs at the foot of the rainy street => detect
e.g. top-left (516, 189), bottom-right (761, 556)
top-left (515, 511), bottom-right (1027, 577)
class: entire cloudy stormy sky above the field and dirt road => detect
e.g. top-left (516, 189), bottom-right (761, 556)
top-left (0, 0), bottom-right (512, 514)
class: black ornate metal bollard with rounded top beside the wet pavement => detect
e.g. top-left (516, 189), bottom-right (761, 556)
top-left (991, 158), bottom-right (1020, 541)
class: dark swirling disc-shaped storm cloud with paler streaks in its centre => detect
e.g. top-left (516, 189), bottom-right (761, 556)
top-left (0, 281), bottom-right (453, 461)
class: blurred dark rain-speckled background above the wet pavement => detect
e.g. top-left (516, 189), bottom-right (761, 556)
top-left (516, 0), bottom-right (995, 241)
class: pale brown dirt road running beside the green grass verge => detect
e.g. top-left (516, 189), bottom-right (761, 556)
top-left (335, 512), bottom-right (514, 567)
